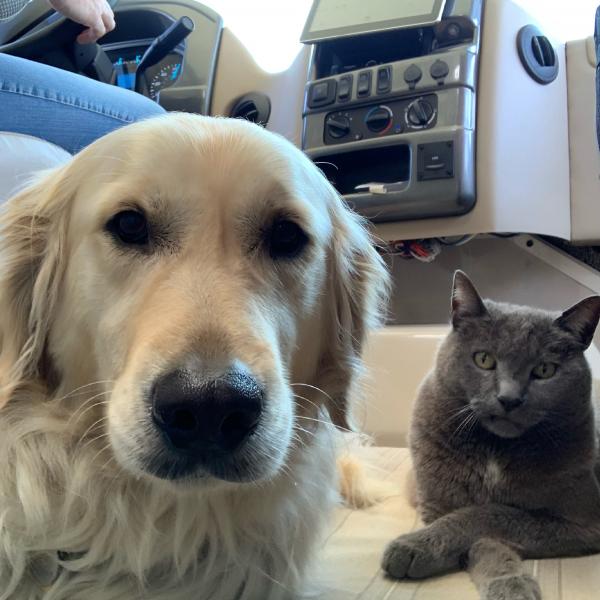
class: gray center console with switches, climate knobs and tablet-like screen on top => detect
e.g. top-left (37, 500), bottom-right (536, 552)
top-left (302, 0), bottom-right (482, 221)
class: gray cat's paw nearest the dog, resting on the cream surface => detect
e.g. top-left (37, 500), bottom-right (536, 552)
top-left (382, 530), bottom-right (460, 579)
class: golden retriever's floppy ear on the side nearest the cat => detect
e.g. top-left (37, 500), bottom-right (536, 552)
top-left (318, 194), bottom-right (390, 429)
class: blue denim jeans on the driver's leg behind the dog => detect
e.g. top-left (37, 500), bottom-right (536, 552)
top-left (0, 53), bottom-right (165, 154)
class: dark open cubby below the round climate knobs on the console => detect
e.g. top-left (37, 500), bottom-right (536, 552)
top-left (315, 144), bottom-right (411, 195)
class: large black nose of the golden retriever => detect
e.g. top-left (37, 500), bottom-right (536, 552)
top-left (152, 370), bottom-right (263, 452)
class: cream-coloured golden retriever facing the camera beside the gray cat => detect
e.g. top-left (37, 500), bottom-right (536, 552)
top-left (0, 114), bottom-right (388, 600)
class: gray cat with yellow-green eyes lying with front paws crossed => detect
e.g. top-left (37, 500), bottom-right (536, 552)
top-left (383, 271), bottom-right (600, 600)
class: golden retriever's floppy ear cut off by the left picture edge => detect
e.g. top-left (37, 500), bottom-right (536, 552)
top-left (0, 165), bottom-right (72, 408)
